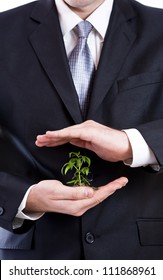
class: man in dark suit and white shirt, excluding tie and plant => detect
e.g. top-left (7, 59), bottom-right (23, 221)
top-left (0, 0), bottom-right (163, 259)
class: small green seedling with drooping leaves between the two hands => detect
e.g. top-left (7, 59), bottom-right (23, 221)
top-left (61, 152), bottom-right (91, 186)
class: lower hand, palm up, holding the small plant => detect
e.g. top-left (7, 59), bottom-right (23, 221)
top-left (24, 177), bottom-right (128, 216)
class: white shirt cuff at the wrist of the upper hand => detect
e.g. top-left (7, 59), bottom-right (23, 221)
top-left (123, 128), bottom-right (160, 171)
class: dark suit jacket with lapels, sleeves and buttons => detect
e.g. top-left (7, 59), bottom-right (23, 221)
top-left (0, 0), bottom-right (163, 259)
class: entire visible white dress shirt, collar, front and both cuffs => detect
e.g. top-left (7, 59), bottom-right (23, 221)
top-left (13, 0), bottom-right (158, 227)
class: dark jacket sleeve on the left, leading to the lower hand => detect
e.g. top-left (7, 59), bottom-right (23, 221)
top-left (0, 126), bottom-right (53, 231)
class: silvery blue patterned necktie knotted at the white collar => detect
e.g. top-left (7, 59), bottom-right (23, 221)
top-left (69, 21), bottom-right (95, 117)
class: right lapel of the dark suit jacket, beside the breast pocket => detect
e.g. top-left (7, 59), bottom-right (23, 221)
top-left (87, 0), bottom-right (136, 119)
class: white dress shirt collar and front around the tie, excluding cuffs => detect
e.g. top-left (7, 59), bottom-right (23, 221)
top-left (55, 0), bottom-right (114, 68)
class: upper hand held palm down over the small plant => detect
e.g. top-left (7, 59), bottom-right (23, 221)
top-left (36, 121), bottom-right (132, 162)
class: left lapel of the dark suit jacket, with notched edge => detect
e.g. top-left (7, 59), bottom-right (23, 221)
top-left (30, 0), bottom-right (82, 123)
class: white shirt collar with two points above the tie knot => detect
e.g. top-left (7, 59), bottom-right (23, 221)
top-left (55, 0), bottom-right (114, 40)
